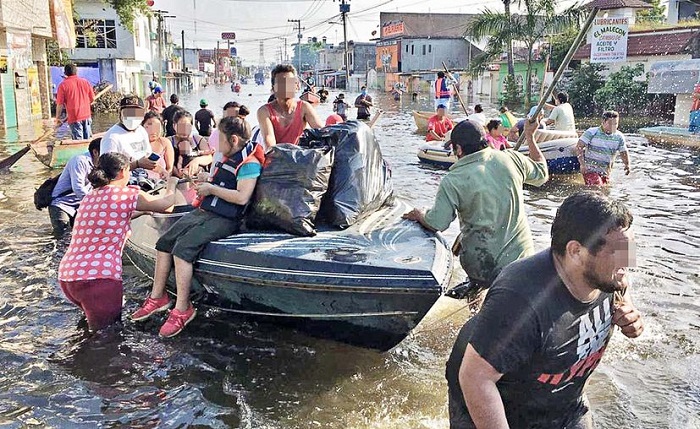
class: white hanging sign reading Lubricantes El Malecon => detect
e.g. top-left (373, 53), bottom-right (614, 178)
top-left (591, 18), bottom-right (629, 63)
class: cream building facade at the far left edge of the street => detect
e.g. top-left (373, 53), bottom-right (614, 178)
top-left (0, 0), bottom-right (53, 129)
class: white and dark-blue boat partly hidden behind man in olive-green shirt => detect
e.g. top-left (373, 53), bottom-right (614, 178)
top-left (418, 137), bottom-right (580, 174)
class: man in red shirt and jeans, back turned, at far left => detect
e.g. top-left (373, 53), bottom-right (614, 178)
top-left (56, 64), bottom-right (95, 140)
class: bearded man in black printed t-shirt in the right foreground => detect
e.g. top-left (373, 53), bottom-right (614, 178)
top-left (446, 191), bottom-right (644, 429)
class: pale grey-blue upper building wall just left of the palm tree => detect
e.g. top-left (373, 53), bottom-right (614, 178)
top-left (401, 38), bottom-right (476, 73)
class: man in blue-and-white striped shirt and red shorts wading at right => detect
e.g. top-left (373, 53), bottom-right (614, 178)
top-left (576, 110), bottom-right (630, 186)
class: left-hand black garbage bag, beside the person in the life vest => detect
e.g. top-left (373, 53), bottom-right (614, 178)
top-left (246, 144), bottom-right (334, 236)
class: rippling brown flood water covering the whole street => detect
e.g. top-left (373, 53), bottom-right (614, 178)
top-left (0, 85), bottom-right (700, 429)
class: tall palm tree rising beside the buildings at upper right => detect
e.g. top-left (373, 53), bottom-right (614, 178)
top-left (467, 0), bottom-right (584, 103)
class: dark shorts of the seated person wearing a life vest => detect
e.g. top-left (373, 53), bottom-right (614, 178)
top-left (156, 209), bottom-right (241, 263)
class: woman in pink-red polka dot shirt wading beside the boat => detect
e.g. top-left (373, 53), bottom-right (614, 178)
top-left (58, 153), bottom-right (177, 330)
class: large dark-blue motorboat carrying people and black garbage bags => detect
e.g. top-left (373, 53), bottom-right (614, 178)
top-left (125, 200), bottom-right (452, 351)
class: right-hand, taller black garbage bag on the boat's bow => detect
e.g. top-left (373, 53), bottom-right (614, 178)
top-left (299, 121), bottom-right (393, 228)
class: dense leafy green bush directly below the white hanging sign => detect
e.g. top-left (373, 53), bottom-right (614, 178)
top-left (594, 64), bottom-right (648, 113)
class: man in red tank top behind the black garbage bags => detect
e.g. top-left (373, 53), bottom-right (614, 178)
top-left (258, 64), bottom-right (323, 150)
